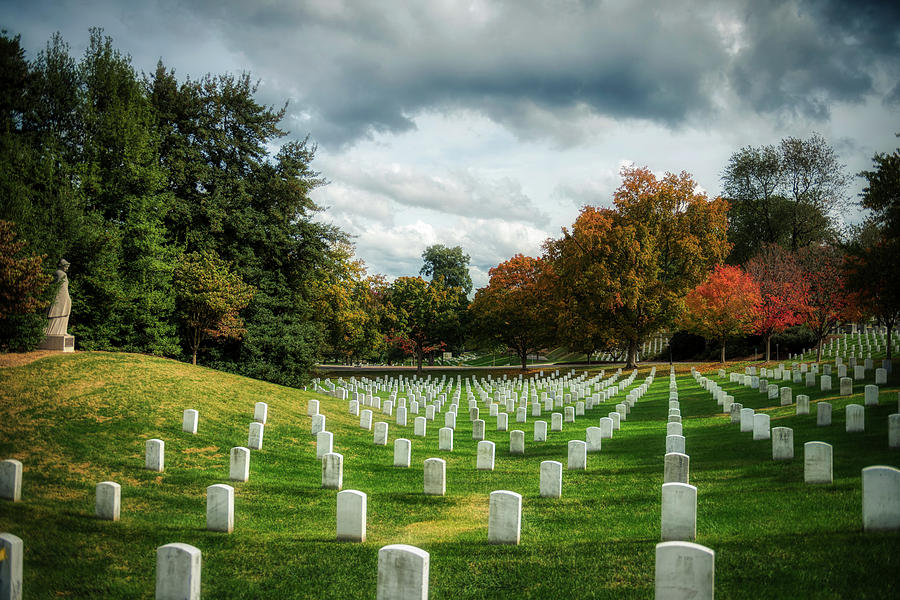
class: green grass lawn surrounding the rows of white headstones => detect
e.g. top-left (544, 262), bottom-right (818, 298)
top-left (0, 352), bottom-right (900, 600)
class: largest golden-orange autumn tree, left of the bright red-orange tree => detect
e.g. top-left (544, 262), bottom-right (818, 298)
top-left (545, 167), bottom-right (728, 368)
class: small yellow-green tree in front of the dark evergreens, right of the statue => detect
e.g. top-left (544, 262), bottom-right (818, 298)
top-left (175, 251), bottom-right (254, 365)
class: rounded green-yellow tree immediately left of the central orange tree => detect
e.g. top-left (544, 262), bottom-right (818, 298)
top-left (385, 277), bottom-right (460, 375)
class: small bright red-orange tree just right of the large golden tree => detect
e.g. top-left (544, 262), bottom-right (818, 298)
top-left (680, 265), bottom-right (761, 364)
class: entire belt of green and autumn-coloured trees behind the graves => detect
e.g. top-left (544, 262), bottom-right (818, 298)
top-left (0, 29), bottom-right (900, 378)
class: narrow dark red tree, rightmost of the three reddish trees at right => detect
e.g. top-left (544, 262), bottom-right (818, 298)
top-left (798, 244), bottom-right (853, 361)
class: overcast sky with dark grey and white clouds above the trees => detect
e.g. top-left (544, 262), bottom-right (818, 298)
top-left (0, 0), bottom-right (900, 287)
